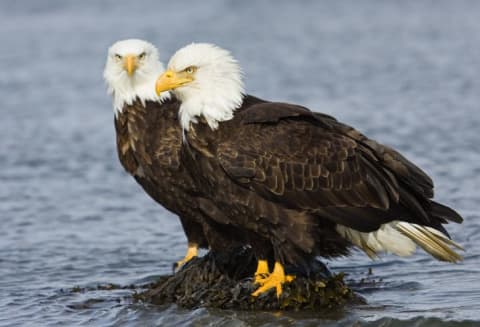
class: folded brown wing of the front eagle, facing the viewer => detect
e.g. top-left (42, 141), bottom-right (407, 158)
top-left (217, 103), bottom-right (458, 231)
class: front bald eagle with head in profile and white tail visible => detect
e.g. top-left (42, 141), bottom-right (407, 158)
top-left (156, 43), bottom-right (462, 296)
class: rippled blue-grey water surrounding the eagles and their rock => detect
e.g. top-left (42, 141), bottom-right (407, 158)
top-left (0, 0), bottom-right (480, 326)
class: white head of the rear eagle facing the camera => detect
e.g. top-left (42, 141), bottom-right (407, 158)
top-left (103, 39), bottom-right (169, 115)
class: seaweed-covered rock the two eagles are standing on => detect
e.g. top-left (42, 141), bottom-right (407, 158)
top-left (134, 249), bottom-right (363, 311)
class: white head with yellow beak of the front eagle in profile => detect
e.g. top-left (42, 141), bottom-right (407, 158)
top-left (156, 43), bottom-right (244, 130)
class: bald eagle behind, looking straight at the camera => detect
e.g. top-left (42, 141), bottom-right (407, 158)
top-left (104, 39), bottom-right (241, 268)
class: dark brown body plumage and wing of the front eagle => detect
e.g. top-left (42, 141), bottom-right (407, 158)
top-left (188, 96), bottom-right (462, 262)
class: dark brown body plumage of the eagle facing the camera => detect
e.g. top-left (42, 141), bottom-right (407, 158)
top-left (115, 99), bottom-right (243, 258)
